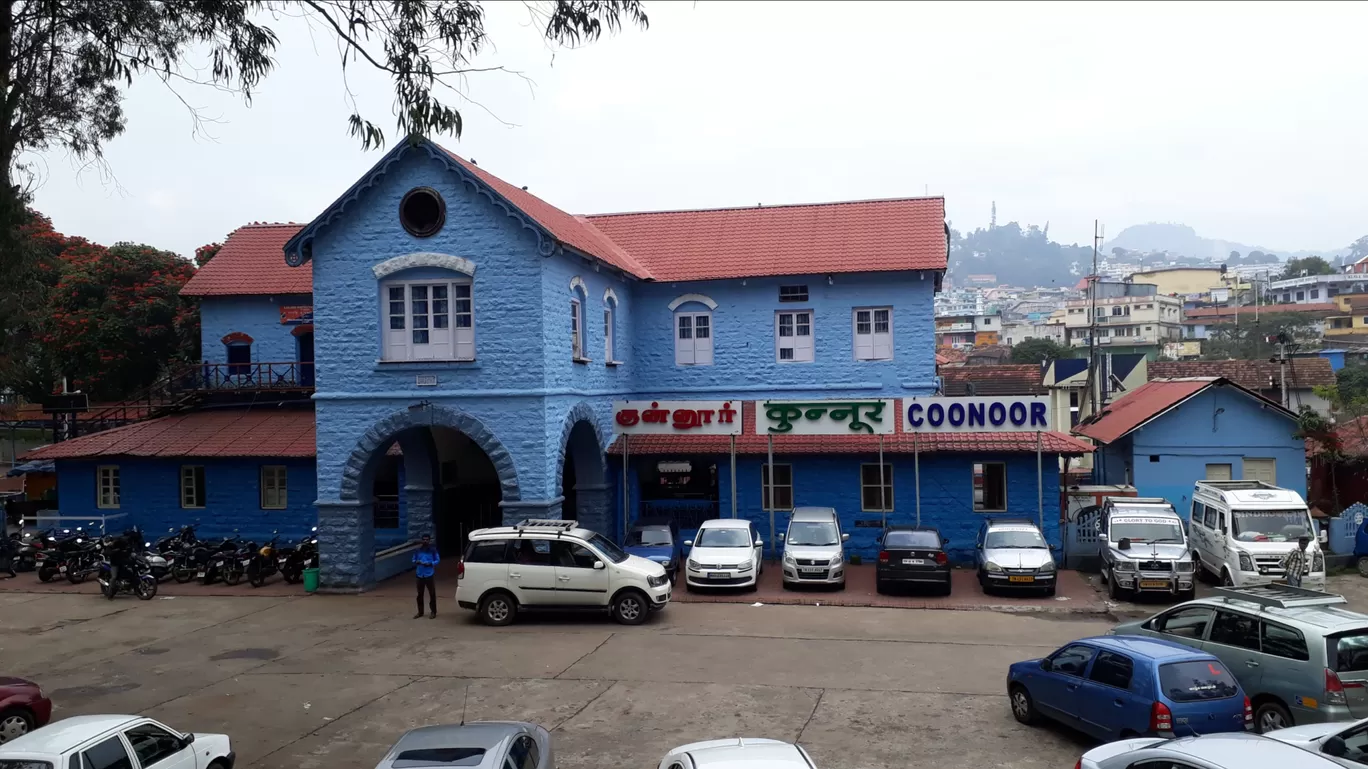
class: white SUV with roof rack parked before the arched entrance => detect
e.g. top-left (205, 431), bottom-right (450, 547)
top-left (456, 520), bottom-right (670, 625)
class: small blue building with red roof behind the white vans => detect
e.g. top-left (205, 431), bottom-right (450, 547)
top-left (1074, 376), bottom-right (1306, 513)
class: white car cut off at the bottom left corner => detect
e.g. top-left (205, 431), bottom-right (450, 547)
top-left (0, 716), bottom-right (237, 769)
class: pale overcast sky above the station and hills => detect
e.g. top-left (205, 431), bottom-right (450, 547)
top-left (24, 1), bottom-right (1368, 255)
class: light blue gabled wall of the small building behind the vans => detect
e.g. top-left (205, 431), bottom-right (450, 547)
top-left (1099, 387), bottom-right (1306, 514)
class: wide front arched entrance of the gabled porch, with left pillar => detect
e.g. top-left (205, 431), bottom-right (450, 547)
top-left (319, 402), bottom-right (521, 588)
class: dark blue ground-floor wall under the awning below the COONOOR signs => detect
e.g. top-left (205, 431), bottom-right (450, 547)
top-left (609, 454), bottom-right (1060, 562)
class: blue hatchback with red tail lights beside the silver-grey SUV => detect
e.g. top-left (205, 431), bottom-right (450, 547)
top-left (1007, 635), bottom-right (1254, 742)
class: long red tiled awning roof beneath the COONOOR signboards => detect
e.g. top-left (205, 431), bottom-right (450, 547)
top-left (607, 400), bottom-right (1093, 456)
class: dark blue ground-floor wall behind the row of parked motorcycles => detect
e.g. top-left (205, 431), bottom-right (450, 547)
top-left (57, 457), bottom-right (316, 542)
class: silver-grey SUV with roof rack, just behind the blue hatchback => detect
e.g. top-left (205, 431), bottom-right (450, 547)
top-left (1111, 584), bottom-right (1368, 732)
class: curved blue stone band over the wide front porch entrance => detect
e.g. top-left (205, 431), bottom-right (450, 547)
top-left (339, 404), bottom-right (523, 502)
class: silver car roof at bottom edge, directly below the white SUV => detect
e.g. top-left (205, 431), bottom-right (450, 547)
top-left (375, 721), bottom-right (555, 769)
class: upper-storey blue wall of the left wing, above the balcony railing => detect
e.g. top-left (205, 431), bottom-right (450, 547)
top-left (200, 294), bottom-right (313, 363)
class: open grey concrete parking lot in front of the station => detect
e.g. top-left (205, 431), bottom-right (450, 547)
top-left (0, 592), bottom-right (1108, 769)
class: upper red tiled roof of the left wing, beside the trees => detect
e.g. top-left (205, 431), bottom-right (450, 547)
top-left (181, 224), bottom-right (313, 297)
